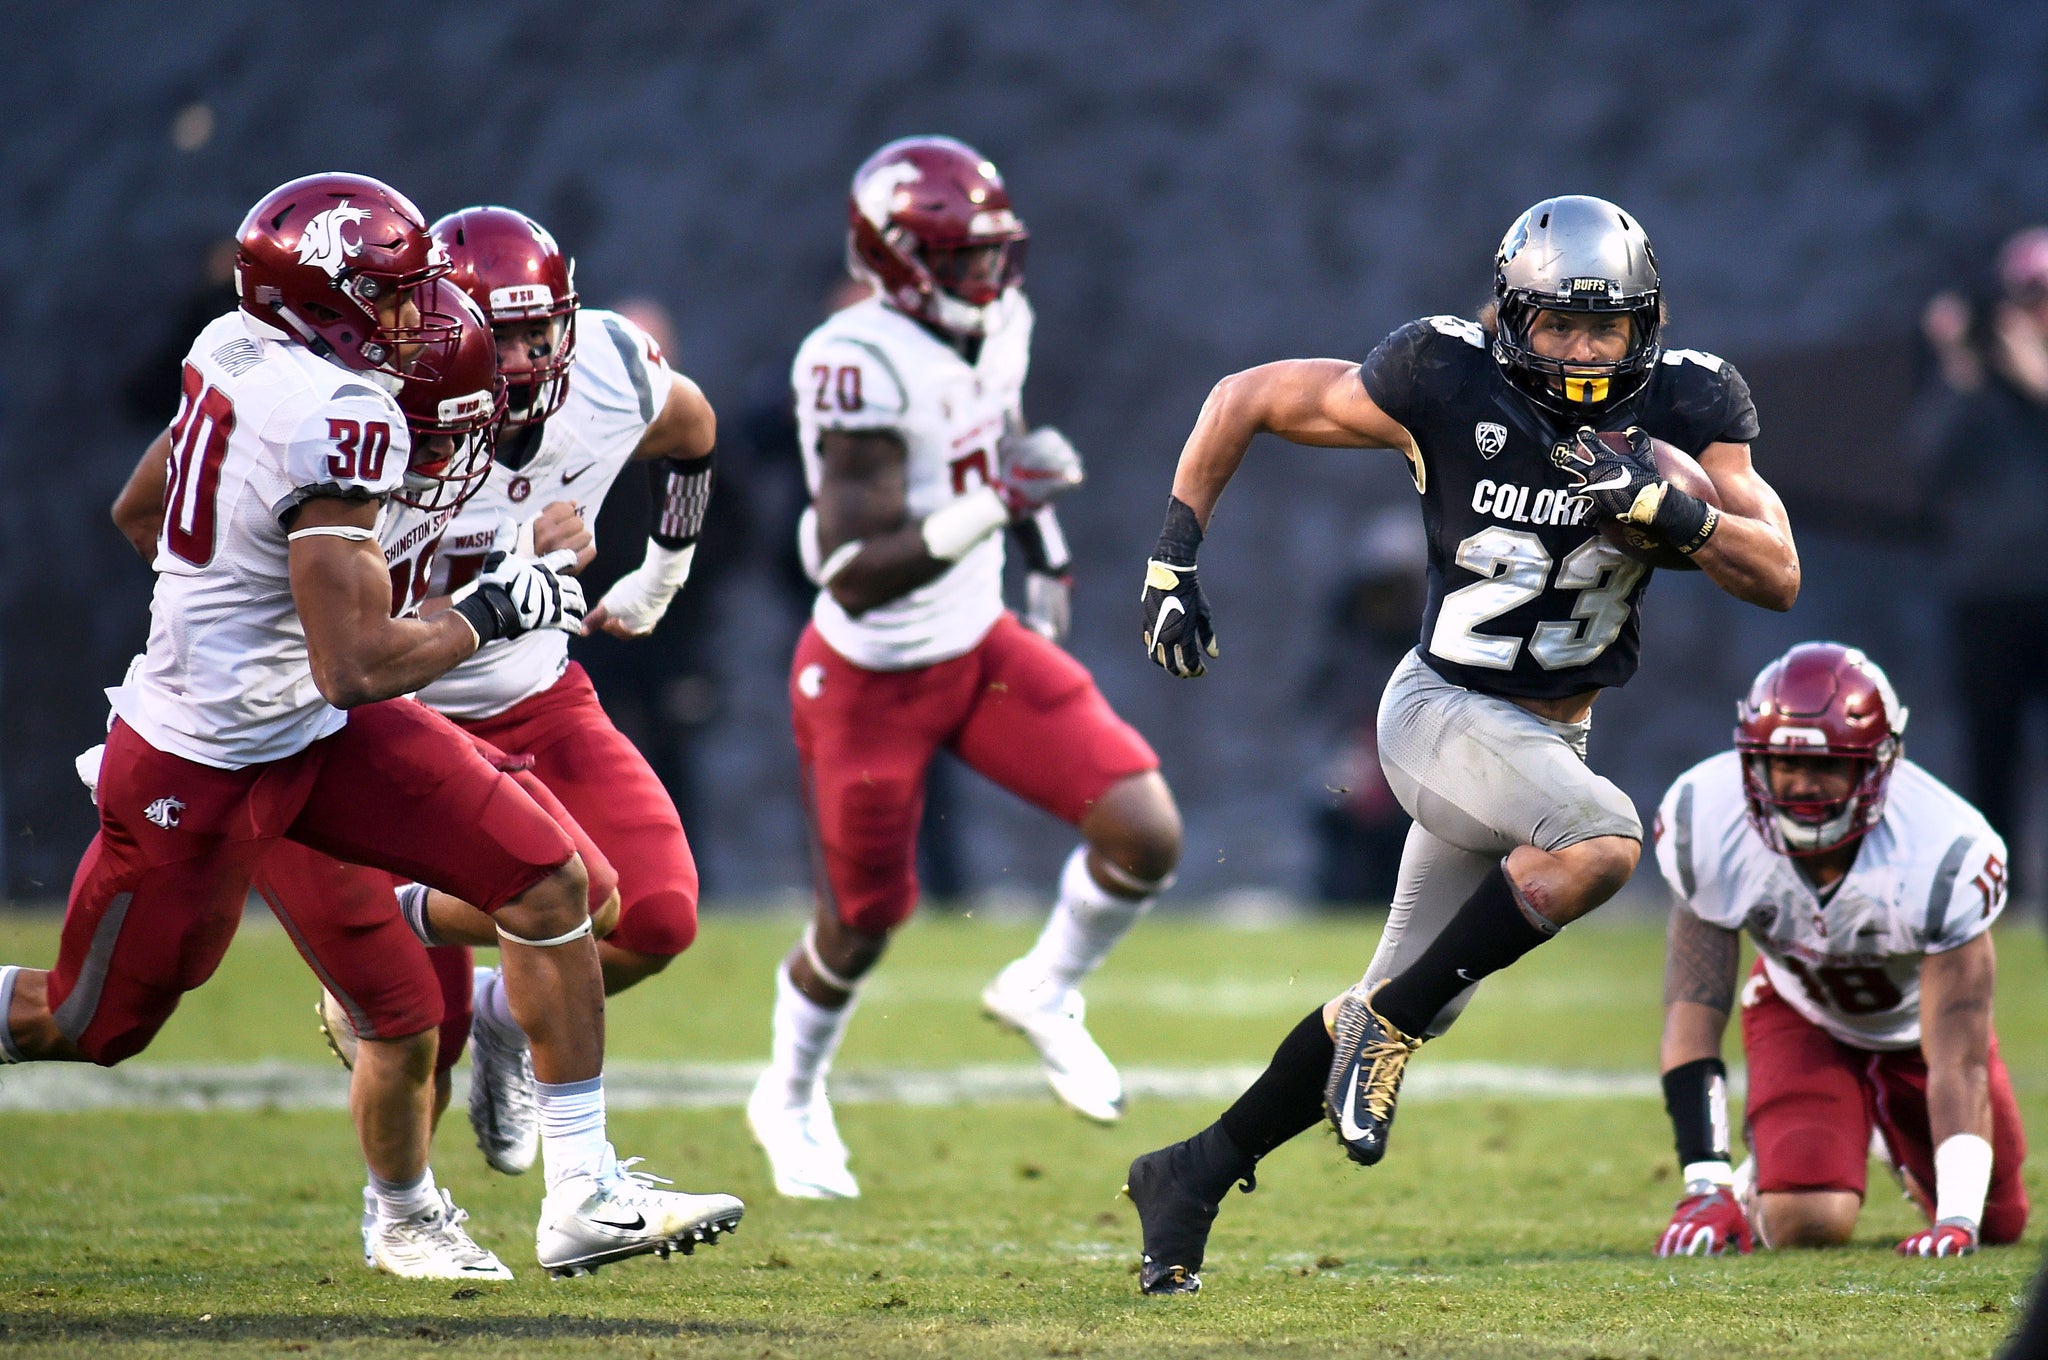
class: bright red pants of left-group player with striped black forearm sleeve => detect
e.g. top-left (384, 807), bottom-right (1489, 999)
top-left (461, 662), bottom-right (696, 959)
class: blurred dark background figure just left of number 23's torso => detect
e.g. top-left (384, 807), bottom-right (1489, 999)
top-left (1303, 516), bottom-right (1425, 905)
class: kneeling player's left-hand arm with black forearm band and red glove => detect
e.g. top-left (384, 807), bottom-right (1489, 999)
top-left (1657, 899), bottom-right (1753, 1256)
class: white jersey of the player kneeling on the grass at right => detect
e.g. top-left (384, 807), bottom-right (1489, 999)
top-left (1655, 752), bottom-right (2005, 1049)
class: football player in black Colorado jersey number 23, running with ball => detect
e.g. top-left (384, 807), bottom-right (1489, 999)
top-left (1128, 197), bottom-right (1800, 1294)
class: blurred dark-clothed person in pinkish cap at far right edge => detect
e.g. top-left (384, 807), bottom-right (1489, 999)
top-left (1913, 227), bottom-right (2048, 895)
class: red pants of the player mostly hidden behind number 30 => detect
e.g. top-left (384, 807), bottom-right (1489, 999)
top-left (250, 737), bottom-right (618, 1040)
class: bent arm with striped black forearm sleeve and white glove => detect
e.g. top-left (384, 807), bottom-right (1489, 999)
top-left (584, 373), bottom-right (719, 637)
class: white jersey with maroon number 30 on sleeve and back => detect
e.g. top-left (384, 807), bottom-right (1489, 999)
top-left (106, 311), bottom-right (412, 770)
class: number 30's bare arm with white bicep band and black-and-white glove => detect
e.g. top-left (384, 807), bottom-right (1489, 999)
top-left (287, 496), bottom-right (584, 709)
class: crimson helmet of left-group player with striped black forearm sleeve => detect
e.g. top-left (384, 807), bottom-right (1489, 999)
top-left (432, 207), bottom-right (578, 428)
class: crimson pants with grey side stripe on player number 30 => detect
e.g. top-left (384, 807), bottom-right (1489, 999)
top-left (49, 698), bottom-right (575, 1065)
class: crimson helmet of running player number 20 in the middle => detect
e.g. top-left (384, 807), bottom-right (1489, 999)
top-left (846, 137), bottom-right (1030, 336)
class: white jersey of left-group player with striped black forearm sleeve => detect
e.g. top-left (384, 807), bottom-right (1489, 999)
top-left (420, 307), bottom-right (674, 719)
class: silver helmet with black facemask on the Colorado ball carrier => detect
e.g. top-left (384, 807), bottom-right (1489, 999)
top-left (1493, 195), bottom-right (1663, 411)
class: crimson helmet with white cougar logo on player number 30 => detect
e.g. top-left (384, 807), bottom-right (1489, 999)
top-left (236, 174), bottom-right (459, 377)
